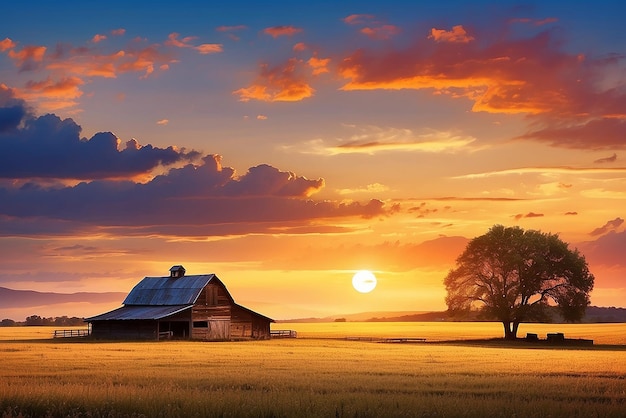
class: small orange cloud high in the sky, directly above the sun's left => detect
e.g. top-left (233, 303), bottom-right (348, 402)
top-left (233, 58), bottom-right (315, 102)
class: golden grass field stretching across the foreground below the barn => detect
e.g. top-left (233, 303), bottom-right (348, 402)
top-left (0, 324), bottom-right (626, 417)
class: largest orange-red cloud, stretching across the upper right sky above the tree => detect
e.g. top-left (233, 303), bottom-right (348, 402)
top-left (339, 27), bottom-right (608, 119)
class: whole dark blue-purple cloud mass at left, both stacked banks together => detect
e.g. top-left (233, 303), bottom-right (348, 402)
top-left (0, 105), bottom-right (392, 237)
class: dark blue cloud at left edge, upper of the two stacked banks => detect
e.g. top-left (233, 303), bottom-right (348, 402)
top-left (0, 105), bottom-right (199, 179)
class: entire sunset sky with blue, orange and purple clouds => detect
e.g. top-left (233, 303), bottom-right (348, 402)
top-left (0, 0), bottom-right (626, 319)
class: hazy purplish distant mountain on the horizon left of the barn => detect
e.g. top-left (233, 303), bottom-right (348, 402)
top-left (0, 287), bottom-right (126, 309)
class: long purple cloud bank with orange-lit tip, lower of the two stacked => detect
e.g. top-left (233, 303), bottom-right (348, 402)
top-left (0, 155), bottom-right (387, 237)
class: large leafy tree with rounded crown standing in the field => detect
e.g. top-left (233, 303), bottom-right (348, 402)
top-left (444, 225), bottom-right (594, 339)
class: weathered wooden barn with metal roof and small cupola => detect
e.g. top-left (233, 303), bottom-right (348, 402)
top-left (85, 265), bottom-right (274, 341)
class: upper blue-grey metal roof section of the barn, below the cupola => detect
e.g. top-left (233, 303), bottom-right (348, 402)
top-left (123, 274), bottom-right (219, 306)
